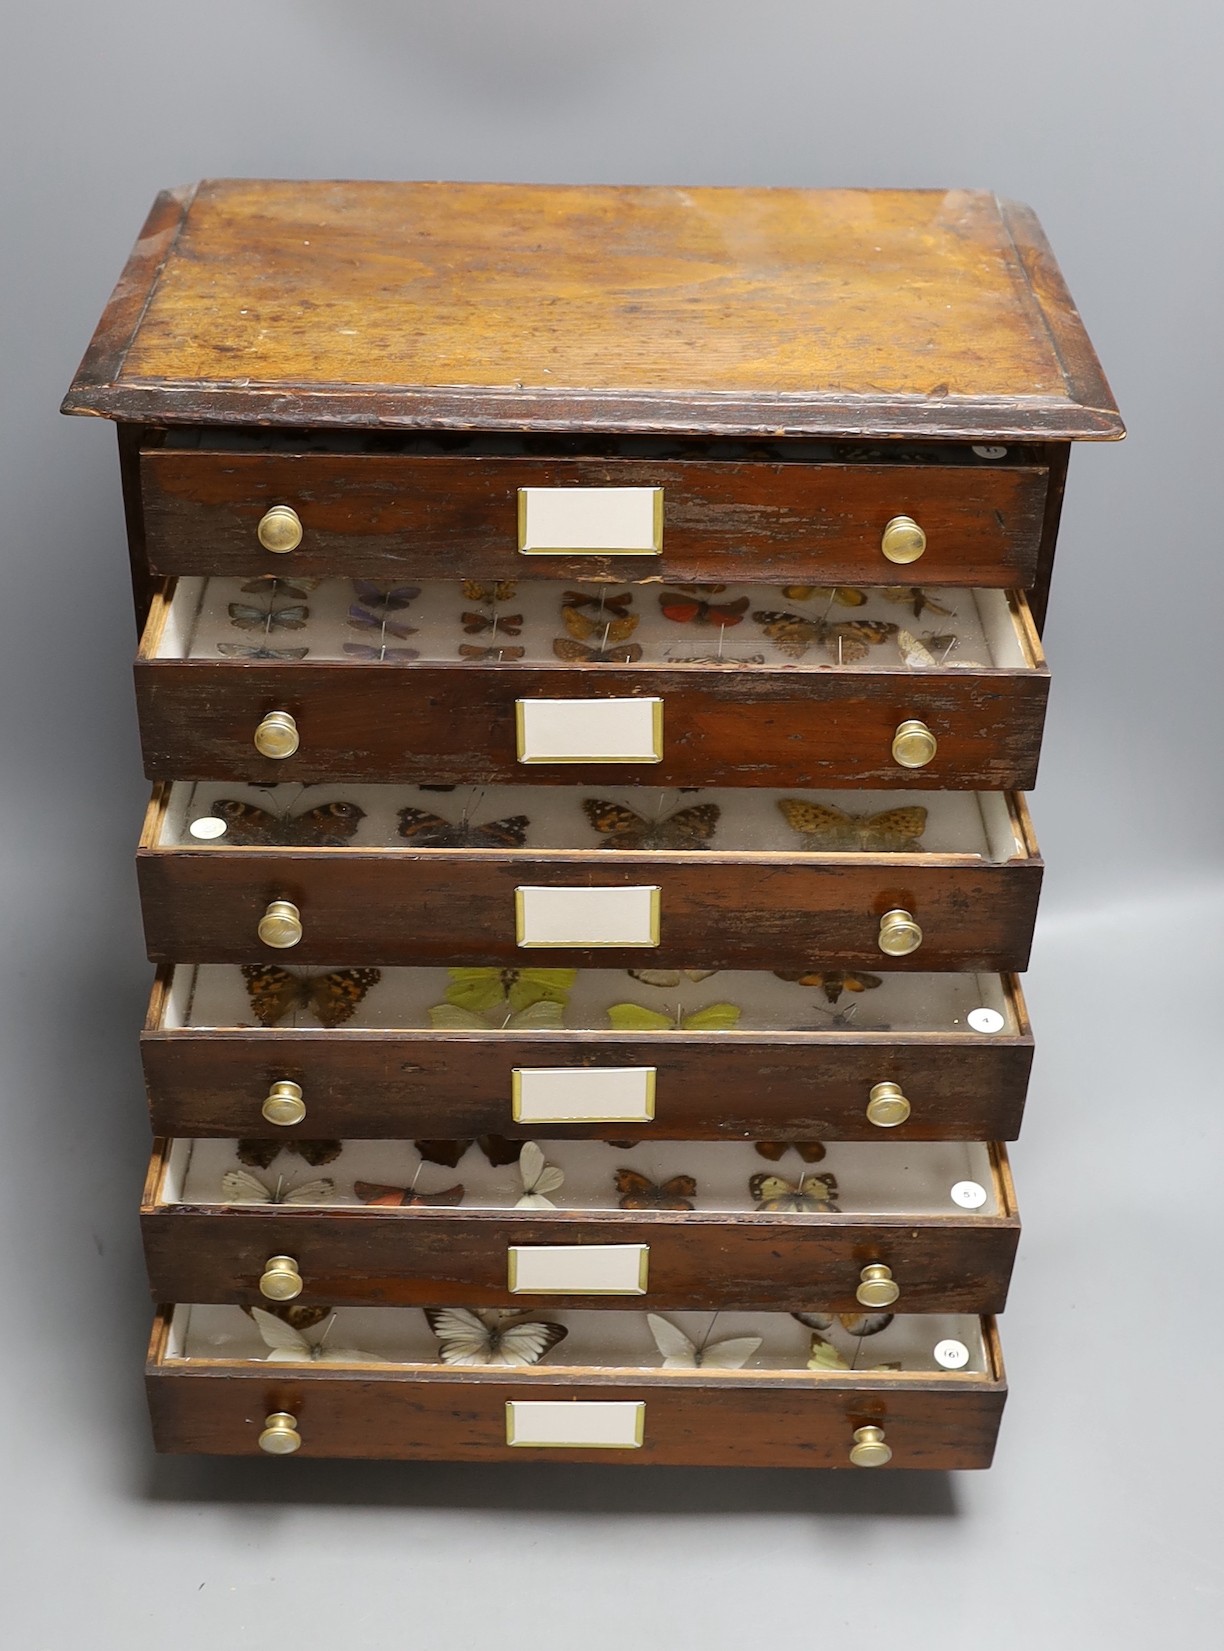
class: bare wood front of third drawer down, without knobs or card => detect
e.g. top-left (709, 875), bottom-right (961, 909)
top-left (137, 849), bottom-right (1041, 972)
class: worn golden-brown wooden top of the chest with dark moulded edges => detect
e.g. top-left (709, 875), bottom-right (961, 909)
top-left (64, 180), bottom-right (1122, 439)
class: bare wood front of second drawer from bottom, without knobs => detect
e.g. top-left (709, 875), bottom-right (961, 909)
top-left (142, 1205), bottom-right (1019, 1313)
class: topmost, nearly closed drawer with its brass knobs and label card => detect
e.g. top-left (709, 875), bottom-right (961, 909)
top-left (140, 429), bottom-right (1049, 586)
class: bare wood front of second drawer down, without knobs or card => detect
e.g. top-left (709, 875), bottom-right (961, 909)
top-left (135, 657), bottom-right (1049, 791)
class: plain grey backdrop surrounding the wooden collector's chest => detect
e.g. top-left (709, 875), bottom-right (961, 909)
top-left (0, 0), bottom-right (1224, 1651)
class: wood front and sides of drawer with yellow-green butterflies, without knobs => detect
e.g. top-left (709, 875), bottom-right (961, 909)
top-left (140, 974), bottom-right (1032, 1141)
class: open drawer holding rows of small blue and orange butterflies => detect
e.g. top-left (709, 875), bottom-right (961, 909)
top-left (135, 578), bottom-right (1049, 791)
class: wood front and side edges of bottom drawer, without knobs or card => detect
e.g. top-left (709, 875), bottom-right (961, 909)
top-left (145, 1309), bottom-right (1008, 1473)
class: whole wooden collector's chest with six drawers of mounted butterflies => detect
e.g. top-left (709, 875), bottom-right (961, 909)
top-left (64, 182), bottom-right (1122, 1468)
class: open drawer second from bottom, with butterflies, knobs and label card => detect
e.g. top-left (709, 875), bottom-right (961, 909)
top-left (142, 1134), bottom-right (1019, 1313)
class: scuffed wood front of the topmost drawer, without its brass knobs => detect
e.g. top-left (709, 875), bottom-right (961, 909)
top-left (140, 447), bottom-right (1049, 588)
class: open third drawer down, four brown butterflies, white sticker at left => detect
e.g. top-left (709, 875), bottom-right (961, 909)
top-left (139, 783), bottom-right (1042, 972)
